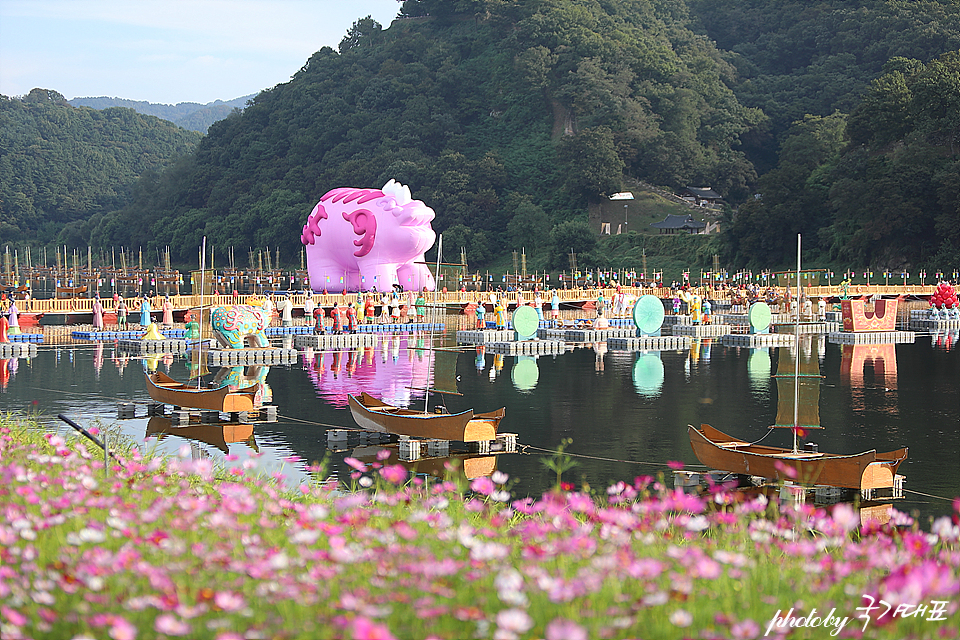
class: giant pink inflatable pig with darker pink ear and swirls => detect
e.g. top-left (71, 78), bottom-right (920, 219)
top-left (300, 180), bottom-right (437, 293)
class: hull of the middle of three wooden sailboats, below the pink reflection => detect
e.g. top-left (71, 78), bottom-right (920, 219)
top-left (348, 393), bottom-right (505, 442)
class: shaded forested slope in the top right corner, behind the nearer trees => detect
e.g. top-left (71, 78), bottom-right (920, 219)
top-left (688, 0), bottom-right (960, 173)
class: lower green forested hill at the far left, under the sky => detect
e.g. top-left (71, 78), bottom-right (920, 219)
top-left (0, 89), bottom-right (201, 246)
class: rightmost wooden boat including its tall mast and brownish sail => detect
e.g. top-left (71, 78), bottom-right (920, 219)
top-left (687, 235), bottom-right (907, 491)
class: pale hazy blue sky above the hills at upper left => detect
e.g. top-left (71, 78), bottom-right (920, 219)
top-left (0, 0), bottom-right (400, 104)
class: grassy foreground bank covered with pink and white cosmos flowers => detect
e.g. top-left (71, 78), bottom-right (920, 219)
top-left (0, 419), bottom-right (960, 640)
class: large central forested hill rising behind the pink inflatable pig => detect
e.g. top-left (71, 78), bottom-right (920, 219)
top-left (92, 0), bottom-right (763, 263)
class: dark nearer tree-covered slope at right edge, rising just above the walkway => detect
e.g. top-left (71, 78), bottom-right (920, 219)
top-left (724, 51), bottom-right (960, 271)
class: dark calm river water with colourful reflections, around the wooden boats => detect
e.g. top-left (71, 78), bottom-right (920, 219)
top-left (0, 315), bottom-right (960, 523)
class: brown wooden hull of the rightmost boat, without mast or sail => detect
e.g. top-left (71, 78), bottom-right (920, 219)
top-left (687, 424), bottom-right (907, 490)
